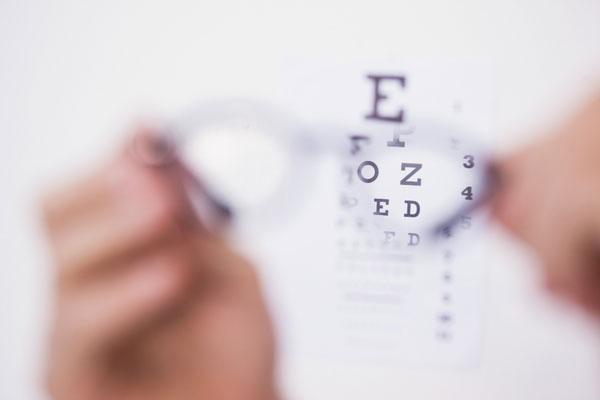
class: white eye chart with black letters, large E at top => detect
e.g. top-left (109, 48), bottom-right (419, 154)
top-left (248, 63), bottom-right (490, 367)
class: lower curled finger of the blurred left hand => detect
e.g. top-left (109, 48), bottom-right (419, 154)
top-left (57, 241), bottom-right (190, 357)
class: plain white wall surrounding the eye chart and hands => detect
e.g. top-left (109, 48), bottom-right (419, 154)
top-left (0, 0), bottom-right (600, 400)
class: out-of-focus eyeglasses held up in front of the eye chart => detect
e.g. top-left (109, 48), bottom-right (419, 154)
top-left (135, 99), bottom-right (498, 247)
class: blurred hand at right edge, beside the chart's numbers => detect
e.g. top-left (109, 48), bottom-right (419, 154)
top-left (495, 98), bottom-right (600, 314)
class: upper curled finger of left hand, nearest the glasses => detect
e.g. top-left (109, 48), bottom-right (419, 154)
top-left (52, 164), bottom-right (177, 274)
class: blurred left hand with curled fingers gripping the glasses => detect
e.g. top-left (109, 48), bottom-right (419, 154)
top-left (45, 135), bottom-right (275, 400)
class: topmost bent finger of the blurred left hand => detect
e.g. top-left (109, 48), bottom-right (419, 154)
top-left (50, 148), bottom-right (192, 280)
